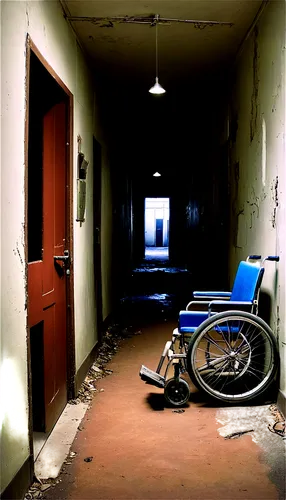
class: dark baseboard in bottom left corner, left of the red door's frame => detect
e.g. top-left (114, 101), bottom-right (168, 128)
top-left (0, 455), bottom-right (34, 500)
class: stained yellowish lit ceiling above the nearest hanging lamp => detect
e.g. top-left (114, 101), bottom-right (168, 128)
top-left (62, 0), bottom-right (264, 86)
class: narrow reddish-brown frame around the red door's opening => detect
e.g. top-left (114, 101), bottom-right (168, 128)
top-left (24, 35), bottom-right (76, 460)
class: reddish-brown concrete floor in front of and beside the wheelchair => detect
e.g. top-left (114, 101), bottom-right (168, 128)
top-left (45, 321), bottom-right (285, 500)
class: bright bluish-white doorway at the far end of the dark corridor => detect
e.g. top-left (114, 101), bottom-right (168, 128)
top-left (144, 198), bottom-right (170, 260)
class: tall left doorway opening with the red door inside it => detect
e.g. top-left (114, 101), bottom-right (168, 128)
top-left (26, 39), bottom-right (74, 461)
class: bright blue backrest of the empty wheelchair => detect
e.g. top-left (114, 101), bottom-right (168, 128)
top-left (230, 261), bottom-right (264, 302)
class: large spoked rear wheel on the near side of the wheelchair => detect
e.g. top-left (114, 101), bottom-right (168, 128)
top-left (187, 311), bottom-right (279, 403)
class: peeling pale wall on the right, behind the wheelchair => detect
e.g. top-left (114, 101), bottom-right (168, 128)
top-left (229, 0), bottom-right (286, 402)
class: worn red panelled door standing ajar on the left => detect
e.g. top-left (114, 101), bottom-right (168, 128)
top-left (28, 102), bottom-right (68, 432)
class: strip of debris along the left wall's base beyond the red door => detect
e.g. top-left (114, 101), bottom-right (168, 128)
top-left (69, 324), bottom-right (141, 406)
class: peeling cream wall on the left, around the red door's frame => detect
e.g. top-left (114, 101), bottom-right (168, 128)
top-left (0, 0), bottom-right (112, 491)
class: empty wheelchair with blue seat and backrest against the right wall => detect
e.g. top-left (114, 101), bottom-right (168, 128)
top-left (139, 255), bottom-right (279, 406)
